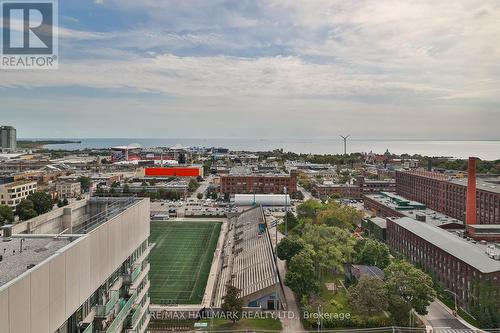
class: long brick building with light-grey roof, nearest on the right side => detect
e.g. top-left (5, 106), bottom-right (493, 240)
top-left (387, 217), bottom-right (500, 309)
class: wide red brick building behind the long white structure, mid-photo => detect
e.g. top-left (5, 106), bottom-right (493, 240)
top-left (220, 171), bottom-right (298, 195)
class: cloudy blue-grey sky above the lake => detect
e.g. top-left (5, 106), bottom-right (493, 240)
top-left (0, 0), bottom-right (500, 140)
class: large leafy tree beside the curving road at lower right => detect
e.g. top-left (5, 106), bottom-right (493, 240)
top-left (385, 261), bottom-right (436, 324)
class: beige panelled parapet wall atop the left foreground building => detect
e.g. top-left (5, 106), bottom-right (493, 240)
top-left (0, 199), bottom-right (149, 333)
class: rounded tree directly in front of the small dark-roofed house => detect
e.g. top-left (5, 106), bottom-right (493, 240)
top-left (348, 277), bottom-right (389, 315)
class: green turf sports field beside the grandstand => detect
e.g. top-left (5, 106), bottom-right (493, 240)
top-left (149, 221), bottom-right (221, 304)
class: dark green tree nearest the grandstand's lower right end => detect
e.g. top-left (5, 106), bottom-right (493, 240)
top-left (285, 250), bottom-right (319, 296)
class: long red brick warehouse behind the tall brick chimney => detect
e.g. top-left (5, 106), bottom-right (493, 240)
top-left (396, 171), bottom-right (500, 224)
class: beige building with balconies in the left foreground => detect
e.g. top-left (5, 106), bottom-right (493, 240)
top-left (0, 198), bottom-right (151, 333)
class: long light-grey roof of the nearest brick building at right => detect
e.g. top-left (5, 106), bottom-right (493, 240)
top-left (390, 217), bottom-right (500, 273)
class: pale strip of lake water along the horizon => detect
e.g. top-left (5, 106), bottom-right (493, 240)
top-left (28, 138), bottom-right (500, 160)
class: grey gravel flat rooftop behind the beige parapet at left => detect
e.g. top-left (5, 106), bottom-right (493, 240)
top-left (0, 235), bottom-right (71, 286)
